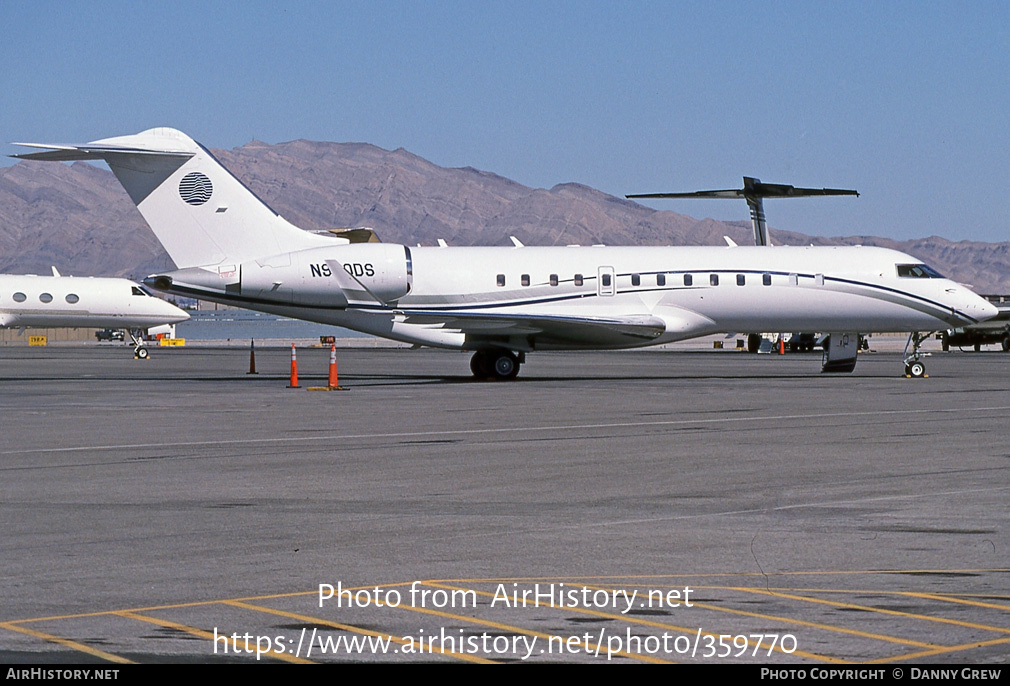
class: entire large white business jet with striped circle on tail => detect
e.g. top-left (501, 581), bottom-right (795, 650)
top-left (15, 128), bottom-right (996, 379)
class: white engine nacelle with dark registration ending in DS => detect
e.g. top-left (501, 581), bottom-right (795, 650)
top-left (238, 243), bottom-right (411, 307)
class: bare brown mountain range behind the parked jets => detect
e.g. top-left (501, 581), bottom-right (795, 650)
top-left (0, 140), bottom-right (1010, 293)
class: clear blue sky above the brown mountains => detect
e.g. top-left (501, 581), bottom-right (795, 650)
top-left (0, 0), bottom-right (1010, 241)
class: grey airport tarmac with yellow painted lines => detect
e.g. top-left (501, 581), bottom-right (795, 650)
top-left (0, 345), bottom-right (1010, 667)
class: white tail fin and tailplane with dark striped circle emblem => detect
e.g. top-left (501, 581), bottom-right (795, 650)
top-left (13, 128), bottom-right (335, 269)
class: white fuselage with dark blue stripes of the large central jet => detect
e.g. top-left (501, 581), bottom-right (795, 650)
top-left (155, 243), bottom-right (995, 351)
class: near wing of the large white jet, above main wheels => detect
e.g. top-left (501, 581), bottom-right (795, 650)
top-left (393, 310), bottom-right (667, 346)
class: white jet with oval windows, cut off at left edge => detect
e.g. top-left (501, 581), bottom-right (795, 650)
top-left (0, 267), bottom-right (189, 358)
